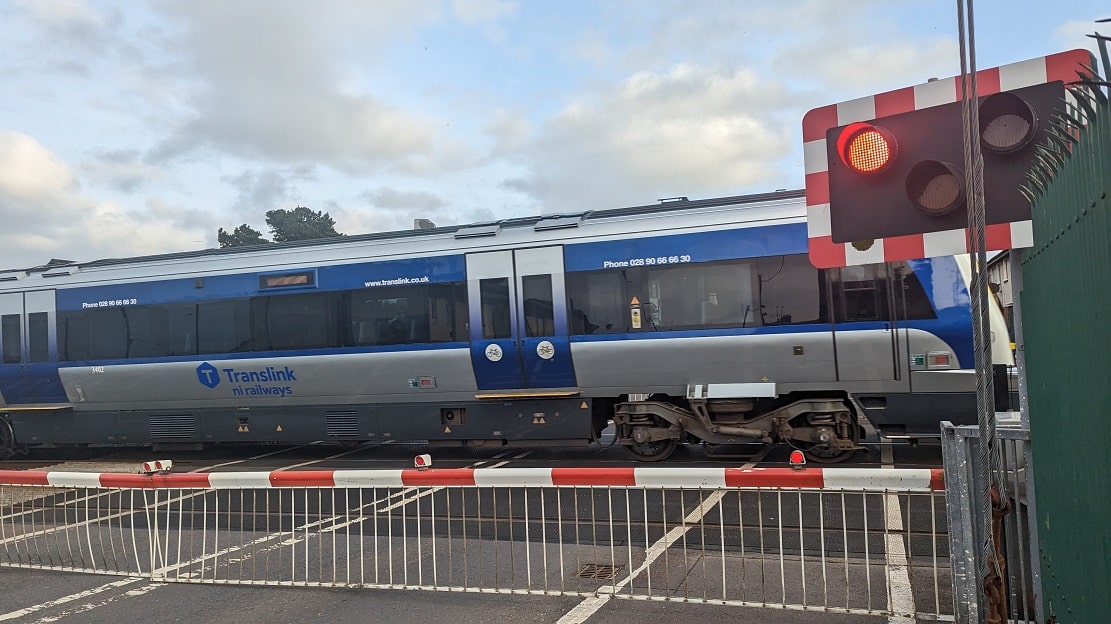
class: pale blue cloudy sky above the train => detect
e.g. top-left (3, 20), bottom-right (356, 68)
top-left (0, 0), bottom-right (1111, 269)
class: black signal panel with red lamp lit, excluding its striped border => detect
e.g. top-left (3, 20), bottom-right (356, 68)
top-left (825, 81), bottom-right (1064, 244)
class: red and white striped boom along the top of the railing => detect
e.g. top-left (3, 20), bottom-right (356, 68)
top-left (0, 467), bottom-right (944, 491)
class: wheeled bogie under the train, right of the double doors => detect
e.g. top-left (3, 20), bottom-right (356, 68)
top-left (613, 395), bottom-right (862, 463)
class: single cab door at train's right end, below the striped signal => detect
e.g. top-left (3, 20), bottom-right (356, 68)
top-left (827, 264), bottom-right (909, 382)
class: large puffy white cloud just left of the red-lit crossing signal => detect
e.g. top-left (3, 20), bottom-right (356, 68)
top-left (519, 64), bottom-right (790, 212)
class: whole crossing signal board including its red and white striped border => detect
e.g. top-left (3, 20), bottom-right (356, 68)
top-left (802, 50), bottom-right (1094, 264)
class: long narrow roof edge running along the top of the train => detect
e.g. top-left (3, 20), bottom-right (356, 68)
top-left (0, 190), bottom-right (805, 282)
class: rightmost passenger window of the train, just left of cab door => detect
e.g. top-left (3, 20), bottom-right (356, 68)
top-left (749, 254), bottom-right (829, 325)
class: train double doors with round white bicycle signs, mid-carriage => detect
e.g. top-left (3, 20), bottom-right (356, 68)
top-left (467, 246), bottom-right (575, 390)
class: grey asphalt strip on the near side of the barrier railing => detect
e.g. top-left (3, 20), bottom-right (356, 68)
top-left (0, 570), bottom-right (888, 624)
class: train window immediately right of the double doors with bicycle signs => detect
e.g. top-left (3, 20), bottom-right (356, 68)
top-left (567, 270), bottom-right (630, 335)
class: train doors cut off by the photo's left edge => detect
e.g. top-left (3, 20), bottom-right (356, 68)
top-left (0, 290), bottom-right (68, 405)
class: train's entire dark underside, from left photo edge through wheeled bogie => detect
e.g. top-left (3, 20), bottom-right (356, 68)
top-left (0, 384), bottom-right (862, 463)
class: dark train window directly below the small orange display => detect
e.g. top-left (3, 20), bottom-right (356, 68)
top-left (251, 293), bottom-right (339, 351)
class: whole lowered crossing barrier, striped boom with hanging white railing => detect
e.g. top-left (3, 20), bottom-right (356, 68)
top-left (0, 467), bottom-right (953, 617)
